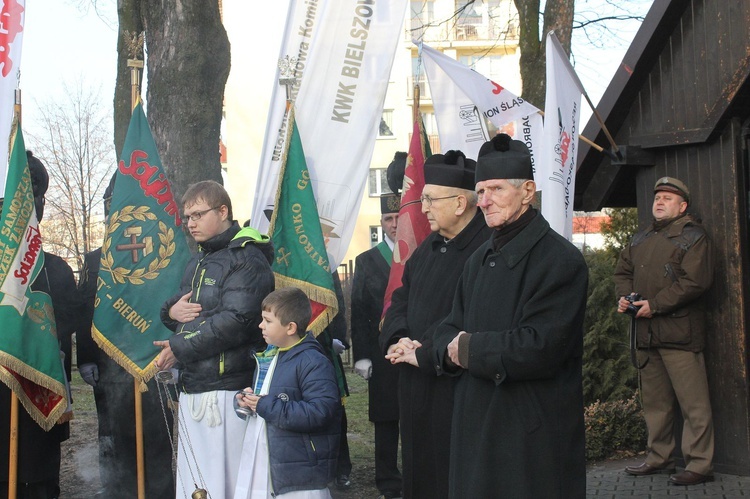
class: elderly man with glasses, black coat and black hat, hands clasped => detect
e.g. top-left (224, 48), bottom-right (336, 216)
top-left (380, 151), bottom-right (492, 499)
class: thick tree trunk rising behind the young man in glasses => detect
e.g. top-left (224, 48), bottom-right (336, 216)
top-left (141, 0), bottom-right (230, 200)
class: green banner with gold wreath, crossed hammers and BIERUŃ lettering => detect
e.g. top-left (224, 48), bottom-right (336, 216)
top-left (92, 103), bottom-right (190, 380)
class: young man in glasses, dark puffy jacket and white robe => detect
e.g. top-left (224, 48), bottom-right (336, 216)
top-left (154, 181), bottom-right (274, 499)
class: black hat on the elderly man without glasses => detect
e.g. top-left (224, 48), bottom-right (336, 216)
top-left (475, 133), bottom-right (534, 182)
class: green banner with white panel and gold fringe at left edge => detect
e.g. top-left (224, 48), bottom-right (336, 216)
top-left (0, 126), bottom-right (67, 430)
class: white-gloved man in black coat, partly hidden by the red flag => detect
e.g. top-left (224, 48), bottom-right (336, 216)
top-left (351, 194), bottom-right (401, 499)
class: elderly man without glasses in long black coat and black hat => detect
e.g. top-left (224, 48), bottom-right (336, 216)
top-left (434, 134), bottom-right (588, 499)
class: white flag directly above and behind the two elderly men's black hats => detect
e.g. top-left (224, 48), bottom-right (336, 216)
top-left (424, 41), bottom-right (543, 169)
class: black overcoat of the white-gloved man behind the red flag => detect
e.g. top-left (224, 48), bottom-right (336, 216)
top-left (351, 242), bottom-right (398, 422)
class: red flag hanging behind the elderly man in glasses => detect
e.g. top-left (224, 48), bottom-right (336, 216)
top-left (383, 113), bottom-right (431, 316)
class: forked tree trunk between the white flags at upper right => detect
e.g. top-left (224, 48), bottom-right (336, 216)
top-left (513, 0), bottom-right (575, 109)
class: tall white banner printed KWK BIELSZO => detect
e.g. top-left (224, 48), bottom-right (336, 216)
top-left (251, 0), bottom-right (408, 267)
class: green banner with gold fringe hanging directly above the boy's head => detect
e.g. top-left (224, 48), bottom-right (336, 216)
top-left (269, 113), bottom-right (338, 335)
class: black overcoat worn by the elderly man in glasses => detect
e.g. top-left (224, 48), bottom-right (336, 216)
top-left (380, 211), bottom-right (492, 499)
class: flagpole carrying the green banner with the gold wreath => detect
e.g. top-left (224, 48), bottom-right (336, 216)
top-left (123, 31), bottom-right (146, 499)
